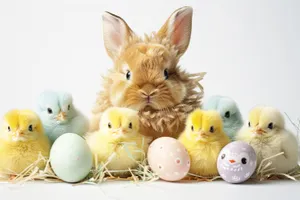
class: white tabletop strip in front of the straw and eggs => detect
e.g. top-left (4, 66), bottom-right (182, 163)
top-left (0, 181), bottom-right (300, 200)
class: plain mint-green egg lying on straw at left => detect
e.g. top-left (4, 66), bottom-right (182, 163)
top-left (50, 133), bottom-right (93, 183)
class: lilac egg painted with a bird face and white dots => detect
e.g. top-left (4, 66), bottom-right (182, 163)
top-left (217, 141), bottom-right (256, 183)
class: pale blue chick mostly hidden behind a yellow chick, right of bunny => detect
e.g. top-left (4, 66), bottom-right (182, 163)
top-left (202, 95), bottom-right (243, 139)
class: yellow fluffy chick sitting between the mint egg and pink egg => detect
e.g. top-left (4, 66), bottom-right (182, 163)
top-left (86, 107), bottom-right (150, 174)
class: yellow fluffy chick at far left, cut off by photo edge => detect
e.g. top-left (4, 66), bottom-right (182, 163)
top-left (0, 110), bottom-right (50, 176)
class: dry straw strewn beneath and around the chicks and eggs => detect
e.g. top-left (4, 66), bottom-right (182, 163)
top-left (0, 120), bottom-right (300, 185)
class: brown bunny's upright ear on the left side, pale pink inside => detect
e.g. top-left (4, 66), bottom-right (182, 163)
top-left (102, 12), bottom-right (134, 60)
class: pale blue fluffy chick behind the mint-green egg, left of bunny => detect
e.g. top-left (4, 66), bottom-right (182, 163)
top-left (37, 91), bottom-right (89, 143)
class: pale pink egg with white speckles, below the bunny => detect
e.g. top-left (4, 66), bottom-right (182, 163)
top-left (148, 137), bottom-right (191, 181)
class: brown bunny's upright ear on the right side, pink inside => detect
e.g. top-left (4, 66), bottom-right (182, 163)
top-left (158, 6), bottom-right (193, 57)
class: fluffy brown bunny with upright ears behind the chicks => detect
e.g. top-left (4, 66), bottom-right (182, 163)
top-left (90, 7), bottom-right (205, 138)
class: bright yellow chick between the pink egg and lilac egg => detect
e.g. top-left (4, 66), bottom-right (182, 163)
top-left (179, 109), bottom-right (230, 177)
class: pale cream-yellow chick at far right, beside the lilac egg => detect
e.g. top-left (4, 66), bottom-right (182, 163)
top-left (236, 107), bottom-right (298, 173)
